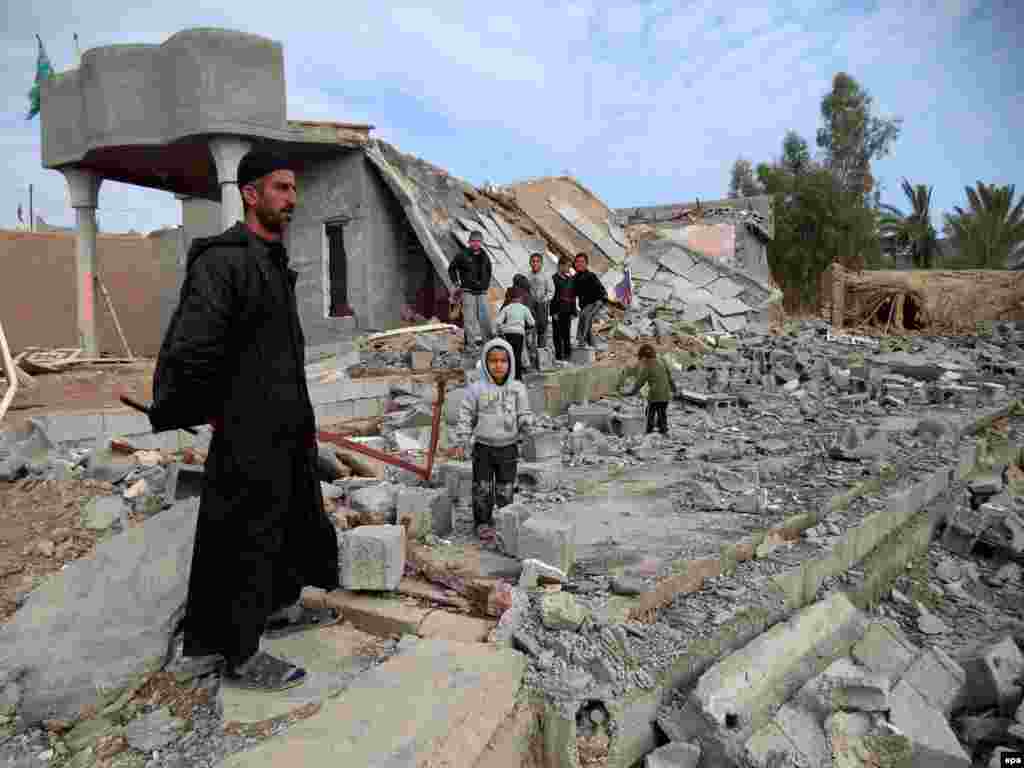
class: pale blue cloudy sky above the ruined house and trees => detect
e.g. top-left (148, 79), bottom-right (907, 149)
top-left (0, 0), bottom-right (1024, 231)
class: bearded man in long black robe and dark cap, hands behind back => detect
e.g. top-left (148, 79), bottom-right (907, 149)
top-left (150, 151), bottom-right (339, 690)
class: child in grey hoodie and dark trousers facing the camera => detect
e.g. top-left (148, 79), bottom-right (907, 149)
top-left (451, 339), bottom-right (534, 540)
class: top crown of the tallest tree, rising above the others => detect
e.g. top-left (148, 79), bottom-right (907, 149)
top-left (817, 72), bottom-right (902, 197)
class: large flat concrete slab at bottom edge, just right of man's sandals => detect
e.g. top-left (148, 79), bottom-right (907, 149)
top-left (220, 640), bottom-right (526, 768)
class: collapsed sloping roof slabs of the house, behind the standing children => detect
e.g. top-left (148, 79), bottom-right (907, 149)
top-left (364, 139), bottom-right (770, 331)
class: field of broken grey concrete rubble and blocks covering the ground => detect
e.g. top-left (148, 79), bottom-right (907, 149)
top-left (0, 319), bottom-right (1024, 768)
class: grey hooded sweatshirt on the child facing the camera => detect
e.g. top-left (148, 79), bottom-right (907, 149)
top-left (455, 339), bottom-right (534, 449)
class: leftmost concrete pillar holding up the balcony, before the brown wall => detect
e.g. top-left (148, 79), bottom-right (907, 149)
top-left (60, 168), bottom-right (103, 357)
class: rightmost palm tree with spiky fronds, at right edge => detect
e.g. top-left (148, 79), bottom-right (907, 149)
top-left (945, 181), bottom-right (1024, 269)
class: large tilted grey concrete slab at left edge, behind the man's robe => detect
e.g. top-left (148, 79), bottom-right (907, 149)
top-left (0, 500), bottom-right (199, 725)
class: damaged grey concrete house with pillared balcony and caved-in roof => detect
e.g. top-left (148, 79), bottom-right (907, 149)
top-left (41, 29), bottom-right (771, 354)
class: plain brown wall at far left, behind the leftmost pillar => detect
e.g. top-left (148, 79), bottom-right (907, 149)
top-left (0, 230), bottom-right (174, 356)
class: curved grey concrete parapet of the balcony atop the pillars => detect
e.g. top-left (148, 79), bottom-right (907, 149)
top-left (41, 29), bottom-right (289, 168)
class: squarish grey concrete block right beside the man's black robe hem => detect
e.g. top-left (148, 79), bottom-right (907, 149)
top-left (339, 525), bottom-right (406, 592)
